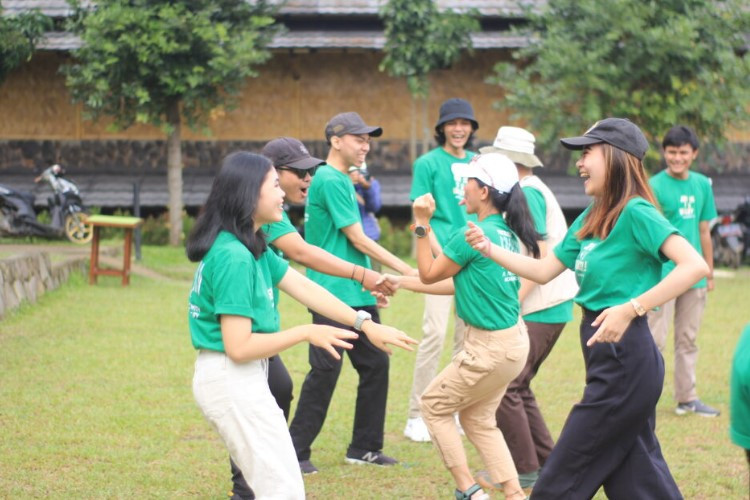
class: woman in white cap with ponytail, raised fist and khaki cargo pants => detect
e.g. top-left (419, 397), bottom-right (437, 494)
top-left (389, 153), bottom-right (540, 500)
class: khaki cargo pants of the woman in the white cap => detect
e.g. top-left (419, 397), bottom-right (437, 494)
top-left (420, 320), bottom-right (529, 483)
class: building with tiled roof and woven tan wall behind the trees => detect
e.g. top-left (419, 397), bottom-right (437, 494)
top-left (0, 0), bottom-right (750, 212)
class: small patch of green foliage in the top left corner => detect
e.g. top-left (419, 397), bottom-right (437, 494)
top-left (0, 5), bottom-right (52, 84)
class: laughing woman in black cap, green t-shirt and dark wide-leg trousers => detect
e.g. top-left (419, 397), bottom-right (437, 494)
top-left (466, 118), bottom-right (708, 500)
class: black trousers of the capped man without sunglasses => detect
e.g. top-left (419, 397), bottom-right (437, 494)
top-left (289, 306), bottom-right (390, 460)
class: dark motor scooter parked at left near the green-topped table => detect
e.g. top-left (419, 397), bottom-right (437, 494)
top-left (0, 164), bottom-right (94, 244)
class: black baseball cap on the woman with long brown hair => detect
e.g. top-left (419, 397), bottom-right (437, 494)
top-left (560, 118), bottom-right (648, 160)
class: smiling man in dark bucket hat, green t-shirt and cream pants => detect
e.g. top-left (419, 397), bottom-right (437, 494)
top-left (404, 98), bottom-right (479, 442)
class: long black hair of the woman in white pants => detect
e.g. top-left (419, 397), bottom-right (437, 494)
top-left (186, 151), bottom-right (273, 262)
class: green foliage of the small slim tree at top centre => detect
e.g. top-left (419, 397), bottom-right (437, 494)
top-left (380, 0), bottom-right (480, 98)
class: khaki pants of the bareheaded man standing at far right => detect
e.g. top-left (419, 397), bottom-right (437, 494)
top-left (648, 288), bottom-right (707, 403)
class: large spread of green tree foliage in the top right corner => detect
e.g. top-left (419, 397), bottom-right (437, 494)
top-left (490, 0), bottom-right (750, 152)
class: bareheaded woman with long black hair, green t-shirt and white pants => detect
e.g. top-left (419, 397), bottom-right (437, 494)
top-left (187, 152), bottom-right (408, 499)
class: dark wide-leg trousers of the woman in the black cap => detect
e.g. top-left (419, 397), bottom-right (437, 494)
top-left (531, 309), bottom-right (682, 500)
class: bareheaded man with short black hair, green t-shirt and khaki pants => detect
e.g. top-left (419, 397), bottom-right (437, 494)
top-left (648, 125), bottom-right (719, 417)
